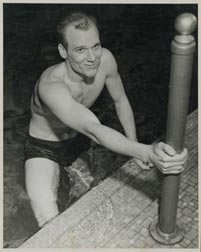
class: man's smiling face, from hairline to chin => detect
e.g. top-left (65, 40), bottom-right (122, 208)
top-left (65, 24), bottom-right (102, 77)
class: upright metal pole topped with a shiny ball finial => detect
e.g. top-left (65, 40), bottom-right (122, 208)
top-left (150, 13), bottom-right (197, 244)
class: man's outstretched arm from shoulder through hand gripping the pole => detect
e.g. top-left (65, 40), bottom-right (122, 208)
top-left (39, 82), bottom-right (186, 173)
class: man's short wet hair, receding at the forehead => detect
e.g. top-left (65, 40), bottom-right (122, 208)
top-left (57, 12), bottom-right (98, 49)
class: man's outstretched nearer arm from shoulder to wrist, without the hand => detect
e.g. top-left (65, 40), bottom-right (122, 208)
top-left (39, 82), bottom-right (150, 161)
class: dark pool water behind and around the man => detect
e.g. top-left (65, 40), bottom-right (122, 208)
top-left (3, 4), bottom-right (198, 247)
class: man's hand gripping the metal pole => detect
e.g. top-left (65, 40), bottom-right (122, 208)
top-left (150, 142), bottom-right (188, 174)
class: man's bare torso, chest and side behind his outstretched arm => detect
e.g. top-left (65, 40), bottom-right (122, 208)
top-left (29, 48), bottom-right (106, 141)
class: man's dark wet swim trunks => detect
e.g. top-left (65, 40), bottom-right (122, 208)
top-left (25, 134), bottom-right (90, 167)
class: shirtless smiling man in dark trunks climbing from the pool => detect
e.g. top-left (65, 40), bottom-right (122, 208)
top-left (25, 13), bottom-right (187, 227)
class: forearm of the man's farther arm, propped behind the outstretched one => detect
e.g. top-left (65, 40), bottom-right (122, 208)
top-left (115, 98), bottom-right (137, 141)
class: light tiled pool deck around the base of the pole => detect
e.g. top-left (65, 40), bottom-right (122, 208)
top-left (19, 111), bottom-right (199, 249)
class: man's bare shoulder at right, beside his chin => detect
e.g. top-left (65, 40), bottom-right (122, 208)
top-left (102, 48), bottom-right (118, 75)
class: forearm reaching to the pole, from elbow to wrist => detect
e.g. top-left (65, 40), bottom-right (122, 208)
top-left (87, 123), bottom-right (151, 162)
